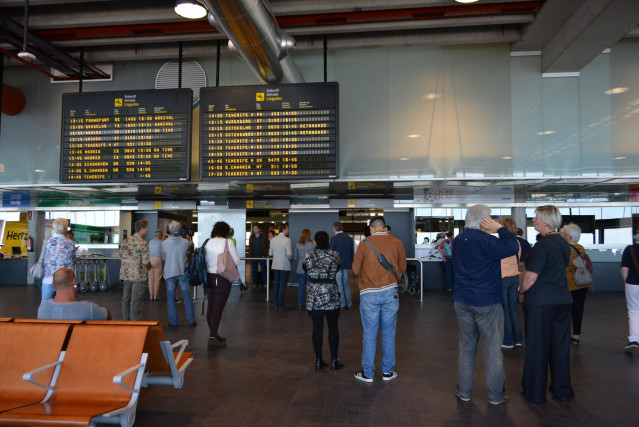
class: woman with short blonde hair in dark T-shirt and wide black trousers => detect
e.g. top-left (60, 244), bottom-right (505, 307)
top-left (519, 205), bottom-right (575, 403)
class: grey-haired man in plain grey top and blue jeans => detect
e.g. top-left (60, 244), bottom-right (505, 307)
top-left (162, 221), bottom-right (197, 328)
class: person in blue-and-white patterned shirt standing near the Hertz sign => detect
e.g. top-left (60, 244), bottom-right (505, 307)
top-left (41, 218), bottom-right (75, 302)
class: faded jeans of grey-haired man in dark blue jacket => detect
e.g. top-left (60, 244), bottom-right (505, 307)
top-left (455, 301), bottom-right (506, 400)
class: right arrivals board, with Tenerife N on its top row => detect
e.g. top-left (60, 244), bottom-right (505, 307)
top-left (200, 83), bottom-right (339, 181)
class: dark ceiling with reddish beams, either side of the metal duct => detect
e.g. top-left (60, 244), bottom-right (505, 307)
top-left (0, 0), bottom-right (639, 72)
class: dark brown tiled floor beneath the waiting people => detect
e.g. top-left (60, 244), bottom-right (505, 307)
top-left (0, 280), bottom-right (639, 427)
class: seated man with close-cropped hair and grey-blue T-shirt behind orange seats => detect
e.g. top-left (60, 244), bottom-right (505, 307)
top-left (38, 268), bottom-right (111, 320)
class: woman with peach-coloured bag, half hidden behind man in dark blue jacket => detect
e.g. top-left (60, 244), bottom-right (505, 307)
top-left (499, 216), bottom-right (524, 348)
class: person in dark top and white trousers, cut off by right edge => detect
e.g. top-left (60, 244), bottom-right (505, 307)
top-left (621, 228), bottom-right (639, 352)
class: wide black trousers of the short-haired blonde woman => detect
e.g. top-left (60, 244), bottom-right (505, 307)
top-left (521, 304), bottom-right (575, 403)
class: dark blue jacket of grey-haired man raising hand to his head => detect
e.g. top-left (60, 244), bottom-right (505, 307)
top-left (453, 227), bottom-right (519, 307)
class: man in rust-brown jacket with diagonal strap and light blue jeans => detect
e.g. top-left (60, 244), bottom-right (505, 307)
top-left (353, 216), bottom-right (406, 383)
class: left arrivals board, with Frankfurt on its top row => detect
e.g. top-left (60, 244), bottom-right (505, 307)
top-left (60, 89), bottom-right (193, 184)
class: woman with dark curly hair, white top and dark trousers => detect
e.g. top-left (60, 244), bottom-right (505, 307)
top-left (204, 221), bottom-right (240, 350)
